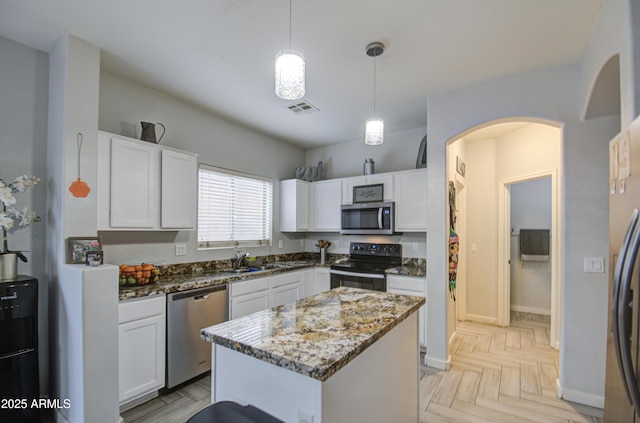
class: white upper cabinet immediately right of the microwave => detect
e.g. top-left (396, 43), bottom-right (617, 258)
top-left (394, 169), bottom-right (427, 232)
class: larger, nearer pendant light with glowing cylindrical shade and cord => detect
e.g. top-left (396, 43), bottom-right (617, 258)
top-left (276, 0), bottom-right (305, 100)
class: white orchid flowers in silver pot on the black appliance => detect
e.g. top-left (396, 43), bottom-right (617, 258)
top-left (0, 175), bottom-right (40, 280)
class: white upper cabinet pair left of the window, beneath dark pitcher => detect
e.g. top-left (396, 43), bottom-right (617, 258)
top-left (97, 133), bottom-right (198, 230)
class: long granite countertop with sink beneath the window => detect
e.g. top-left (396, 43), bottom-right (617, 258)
top-left (118, 261), bottom-right (328, 301)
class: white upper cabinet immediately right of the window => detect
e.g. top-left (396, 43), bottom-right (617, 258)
top-left (280, 179), bottom-right (310, 232)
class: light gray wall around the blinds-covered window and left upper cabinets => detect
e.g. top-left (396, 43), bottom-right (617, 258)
top-left (99, 71), bottom-right (304, 264)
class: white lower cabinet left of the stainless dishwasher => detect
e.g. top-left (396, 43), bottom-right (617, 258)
top-left (118, 295), bottom-right (166, 408)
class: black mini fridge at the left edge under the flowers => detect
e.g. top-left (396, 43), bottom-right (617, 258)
top-left (0, 276), bottom-right (40, 423)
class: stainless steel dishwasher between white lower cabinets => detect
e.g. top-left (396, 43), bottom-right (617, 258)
top-left (166, 284), bottom-right (229, 388)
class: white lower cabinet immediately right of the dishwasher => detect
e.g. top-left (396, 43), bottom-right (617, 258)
top-left (229, 277), bottom-right (271, 319)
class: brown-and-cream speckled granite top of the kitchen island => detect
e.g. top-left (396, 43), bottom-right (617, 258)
top-left (201, 287), bottom-right (425, 381)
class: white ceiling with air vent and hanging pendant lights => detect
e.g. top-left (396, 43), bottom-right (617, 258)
top-left (0, 0), bottom-right (602, 148)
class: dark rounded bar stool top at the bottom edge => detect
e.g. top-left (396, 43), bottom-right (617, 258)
top-left (187, 401), bottom-right (284, 423)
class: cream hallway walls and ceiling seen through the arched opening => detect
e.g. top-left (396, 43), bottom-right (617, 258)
top-left (447, 118), bottom-right (562, 348)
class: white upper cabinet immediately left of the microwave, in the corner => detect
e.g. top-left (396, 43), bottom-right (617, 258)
top-left (311, 179), bottom-right (342, 232)
